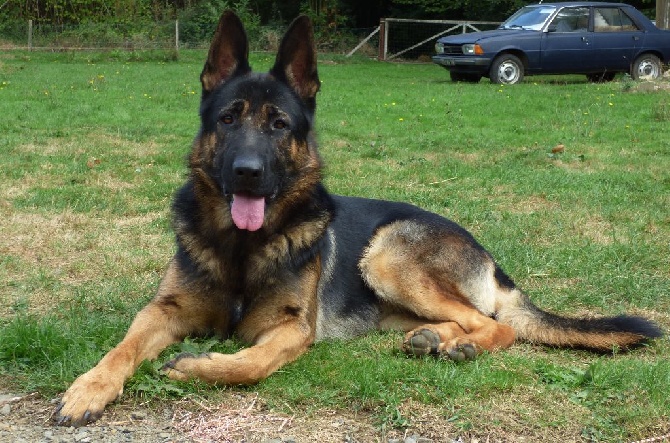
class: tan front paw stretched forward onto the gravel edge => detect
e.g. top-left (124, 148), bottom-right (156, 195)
top-left (51, 370), bottom-right (123, 427)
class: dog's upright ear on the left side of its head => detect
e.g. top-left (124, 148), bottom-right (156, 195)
top-left (200, 11), bottom-right (251, 96)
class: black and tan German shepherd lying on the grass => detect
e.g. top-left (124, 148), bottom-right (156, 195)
top-left (53, 12), bottom-right (662, 426)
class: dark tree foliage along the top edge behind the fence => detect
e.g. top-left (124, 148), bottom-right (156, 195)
top-left (0, 0), bottom-right (656, 27)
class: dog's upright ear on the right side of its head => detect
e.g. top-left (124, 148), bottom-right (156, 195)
top-left (270, 15), bottom-right (321, 111)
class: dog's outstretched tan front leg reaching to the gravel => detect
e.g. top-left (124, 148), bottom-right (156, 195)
top-left (53, 263), bottom-right (218, 426)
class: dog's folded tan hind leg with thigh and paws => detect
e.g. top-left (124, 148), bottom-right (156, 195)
top-left (360, 220), bottom-right (515, 360)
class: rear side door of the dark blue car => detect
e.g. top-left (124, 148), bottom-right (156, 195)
top-left (593, 6), bottom-right (645, 71)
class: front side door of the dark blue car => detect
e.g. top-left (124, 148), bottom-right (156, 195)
top-left (539, 6), bottom-right (596, 74)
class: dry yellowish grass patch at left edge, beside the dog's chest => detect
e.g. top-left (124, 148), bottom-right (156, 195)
top-left (0, 208), bottom-right (168, 317)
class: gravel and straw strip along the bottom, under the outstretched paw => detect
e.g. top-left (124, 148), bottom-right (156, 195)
top-left (0, 392), bottom-right (446, 443)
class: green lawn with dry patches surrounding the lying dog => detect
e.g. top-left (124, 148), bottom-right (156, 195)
top-left (0, 51), bottom-right (670, 441)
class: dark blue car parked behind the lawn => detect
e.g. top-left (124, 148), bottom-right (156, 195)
top-left (433, 2), bottom-right (670, 84)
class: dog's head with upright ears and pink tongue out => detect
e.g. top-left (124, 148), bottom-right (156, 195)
top-left (190, 12), bottom-right (321, 231)
